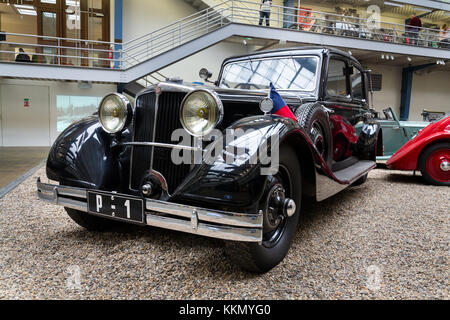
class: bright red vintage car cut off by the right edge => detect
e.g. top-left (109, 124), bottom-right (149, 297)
top-left (386, 114), bottom-right (450, 186)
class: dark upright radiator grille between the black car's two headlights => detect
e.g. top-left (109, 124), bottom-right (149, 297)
top-left (130, 92), bottom-right (190, 193)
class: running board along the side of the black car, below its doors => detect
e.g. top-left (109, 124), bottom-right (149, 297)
top-left (316, 160), bottom-right (377, 201)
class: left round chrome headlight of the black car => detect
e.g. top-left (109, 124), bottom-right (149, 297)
top-left (98, 93), bottom-right (133, 134)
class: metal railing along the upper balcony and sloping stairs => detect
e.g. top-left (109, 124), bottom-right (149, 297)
top-left (0, 0), bottom-right (450, 73)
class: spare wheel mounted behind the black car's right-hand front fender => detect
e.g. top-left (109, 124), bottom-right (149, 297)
top-left (295, 103), bottom-right (333, 166)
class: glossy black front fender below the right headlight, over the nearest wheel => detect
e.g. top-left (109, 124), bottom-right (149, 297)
top-left (172, 115), bottom-right (299, 211)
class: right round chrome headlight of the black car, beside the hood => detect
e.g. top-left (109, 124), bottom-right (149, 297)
top-left (180, 89), bottom-right (223, 137)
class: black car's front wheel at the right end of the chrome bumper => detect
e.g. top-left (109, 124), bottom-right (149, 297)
top-left (225, 145), bottom-right (302, 273)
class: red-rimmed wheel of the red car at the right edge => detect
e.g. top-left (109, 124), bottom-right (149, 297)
top-left (419, 142), bottom-right (450, 186)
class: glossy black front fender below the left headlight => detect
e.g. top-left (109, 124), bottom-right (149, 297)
top-left (47, 116), bottom-right (130, 190)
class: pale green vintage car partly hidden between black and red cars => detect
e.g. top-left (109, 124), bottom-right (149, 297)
top-left (355, 107), bottom-right (430, 161)
